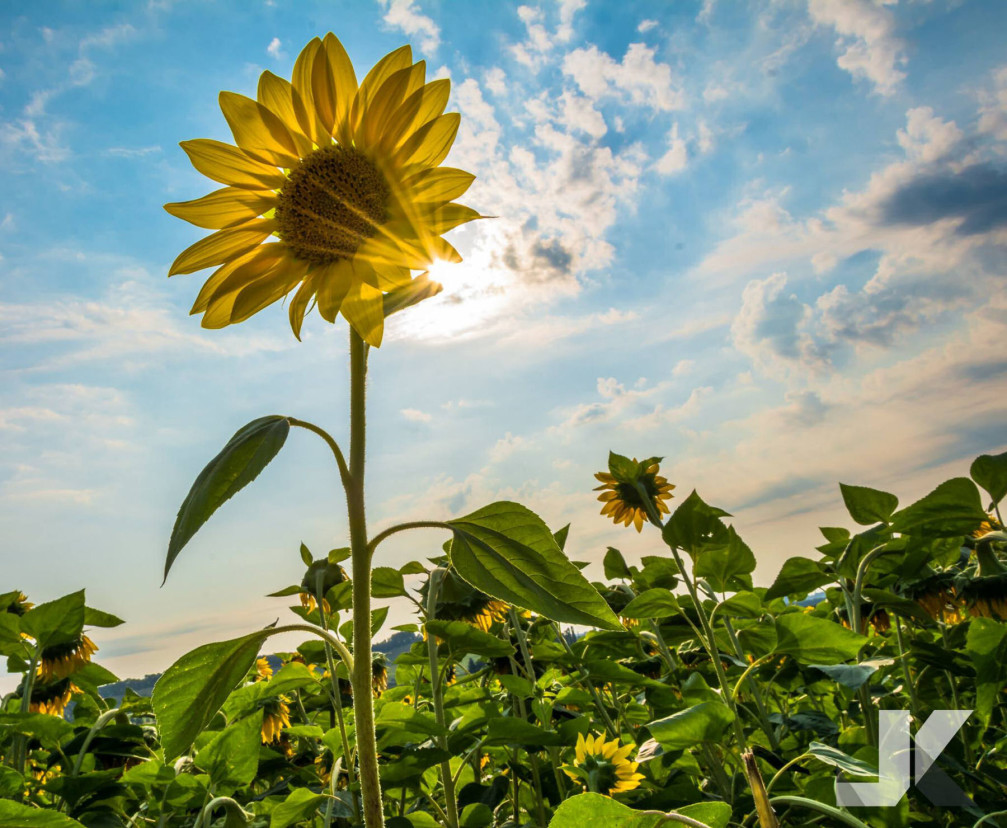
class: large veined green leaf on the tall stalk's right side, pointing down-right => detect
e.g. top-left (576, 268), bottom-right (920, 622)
top-left (449, 501), bottom-right (622, 630)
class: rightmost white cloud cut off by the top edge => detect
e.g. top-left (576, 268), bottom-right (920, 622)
top-left (808, 0), bottom-right (906, 95)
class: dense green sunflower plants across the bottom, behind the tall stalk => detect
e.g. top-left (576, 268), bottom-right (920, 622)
top-left (0, 454), bottom-right (1007, 828)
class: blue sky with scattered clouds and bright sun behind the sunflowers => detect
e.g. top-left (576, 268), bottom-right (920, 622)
top-left (0, 0), bottom-right (1007, 688)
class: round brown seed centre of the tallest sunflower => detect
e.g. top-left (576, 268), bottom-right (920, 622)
top-left (276, 145), bottom-right (391, 265)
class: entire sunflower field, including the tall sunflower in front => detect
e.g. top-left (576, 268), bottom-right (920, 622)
top-left (0, 29), bottom-right (1007, 828)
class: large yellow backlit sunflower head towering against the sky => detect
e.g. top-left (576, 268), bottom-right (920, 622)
top-left (164, 33), bottom-right (479, 346)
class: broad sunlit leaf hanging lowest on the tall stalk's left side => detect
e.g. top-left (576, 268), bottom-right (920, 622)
top-left (151, 631), bottom-right (269, 762)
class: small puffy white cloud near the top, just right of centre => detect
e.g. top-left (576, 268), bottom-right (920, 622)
top-left (563, 43), bottom-right (685, 112)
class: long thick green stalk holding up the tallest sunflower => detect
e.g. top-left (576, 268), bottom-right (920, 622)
top-left (345, 328), bottom-right (385, 828)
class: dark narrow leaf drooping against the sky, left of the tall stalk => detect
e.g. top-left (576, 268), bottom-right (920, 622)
top-left (164, 415), bottom-right (290, 580)
